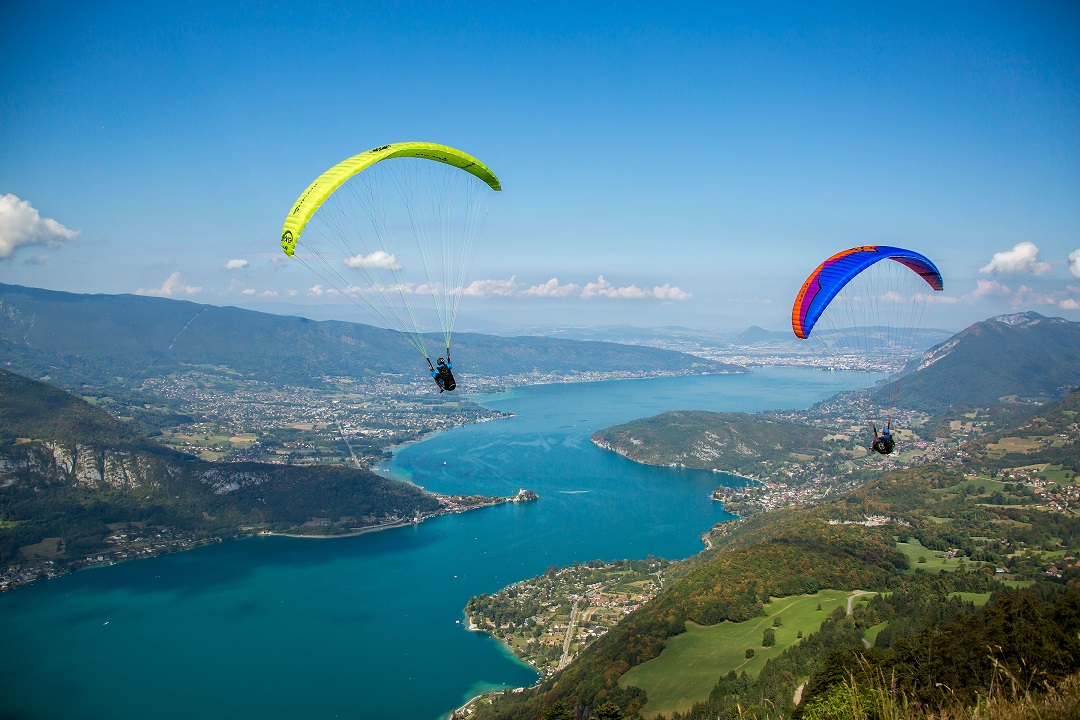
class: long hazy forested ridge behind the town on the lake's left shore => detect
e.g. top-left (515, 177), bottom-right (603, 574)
top-left (0, 285), bottom-right (745, 395)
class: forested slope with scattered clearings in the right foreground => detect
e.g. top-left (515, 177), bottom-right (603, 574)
top-left (476, 393), bottom-right (1080, 720)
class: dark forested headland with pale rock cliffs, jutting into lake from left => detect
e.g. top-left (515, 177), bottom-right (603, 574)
top-left (0, 370), bottom-right (440, 565)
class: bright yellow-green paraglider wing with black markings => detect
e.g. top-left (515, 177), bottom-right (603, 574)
top-left (281, 142), bottom-right (502, 257)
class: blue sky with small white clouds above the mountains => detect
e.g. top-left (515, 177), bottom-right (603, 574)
top-left (0, 2), bottom-right (1080, 329)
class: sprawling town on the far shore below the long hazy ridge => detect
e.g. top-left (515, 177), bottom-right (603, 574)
top-left (132, 370), bottom-right (734, 467)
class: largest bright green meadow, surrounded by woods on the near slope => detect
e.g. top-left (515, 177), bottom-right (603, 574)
top-left (619, 590), bottom-right (850, 718)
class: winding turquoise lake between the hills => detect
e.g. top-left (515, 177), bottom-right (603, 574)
top-left (0, 368), bottom-right (851, 720)
